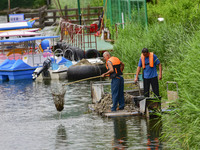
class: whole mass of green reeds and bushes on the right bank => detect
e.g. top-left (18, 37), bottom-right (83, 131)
top-left (111, 0), bottom-right (200, 149)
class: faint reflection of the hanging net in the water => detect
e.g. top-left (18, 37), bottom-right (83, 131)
top-left (55, 124), bottom-right (68, 149)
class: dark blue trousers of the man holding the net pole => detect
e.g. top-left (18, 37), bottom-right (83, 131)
top-left (111, 76), bottom-right (125, 111)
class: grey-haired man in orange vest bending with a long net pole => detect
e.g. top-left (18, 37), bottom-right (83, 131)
top-left (101, 51), bottom-right (125, 112)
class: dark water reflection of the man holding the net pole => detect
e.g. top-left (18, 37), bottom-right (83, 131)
top-left (113, 117), bottom-right (128, 150)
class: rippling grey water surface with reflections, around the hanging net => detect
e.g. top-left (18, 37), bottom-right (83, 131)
top-left (0, 81), bottom-right (162, 150)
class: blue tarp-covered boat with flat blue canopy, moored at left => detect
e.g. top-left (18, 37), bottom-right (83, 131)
top-left (0, 36), bottom-right (59, 80)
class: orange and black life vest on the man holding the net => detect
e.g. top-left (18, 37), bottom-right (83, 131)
top-left (106, 57), bottom-right (123, 79)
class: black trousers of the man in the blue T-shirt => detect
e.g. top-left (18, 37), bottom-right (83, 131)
top-left (143, 77), bottom-right (159, 97)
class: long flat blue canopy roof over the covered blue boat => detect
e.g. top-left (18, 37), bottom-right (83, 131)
top-left (0, 36), bottom-right (60, 43)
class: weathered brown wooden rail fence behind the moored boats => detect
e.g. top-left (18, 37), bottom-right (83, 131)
top-left (2, 6), bottom-right (103, 28)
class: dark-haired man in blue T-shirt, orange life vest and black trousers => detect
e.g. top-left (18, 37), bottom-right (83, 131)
top-left (135, 48), bottom-right (162, 97)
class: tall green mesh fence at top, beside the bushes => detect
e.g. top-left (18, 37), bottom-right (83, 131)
top-left (104, 0), bottom-right (147, 26)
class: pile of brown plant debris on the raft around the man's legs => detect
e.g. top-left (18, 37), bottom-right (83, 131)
top-left (89, 93), bottom-right (139, 115)
